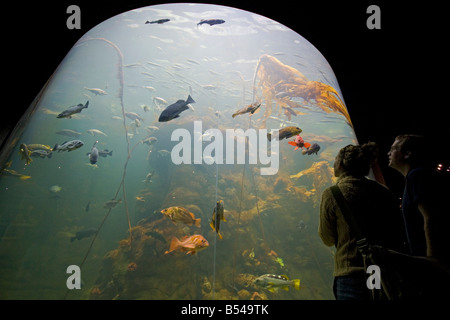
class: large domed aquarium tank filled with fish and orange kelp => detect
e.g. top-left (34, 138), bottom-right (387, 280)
top-left (0, 3), bottom-right (357, 300)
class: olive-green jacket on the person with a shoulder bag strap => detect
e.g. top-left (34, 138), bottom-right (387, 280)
top-left (319, 175), bottom-right (405, 277)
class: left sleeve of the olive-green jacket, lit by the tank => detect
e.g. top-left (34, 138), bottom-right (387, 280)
top-left (319, 188), bottom-right (337, 246)
